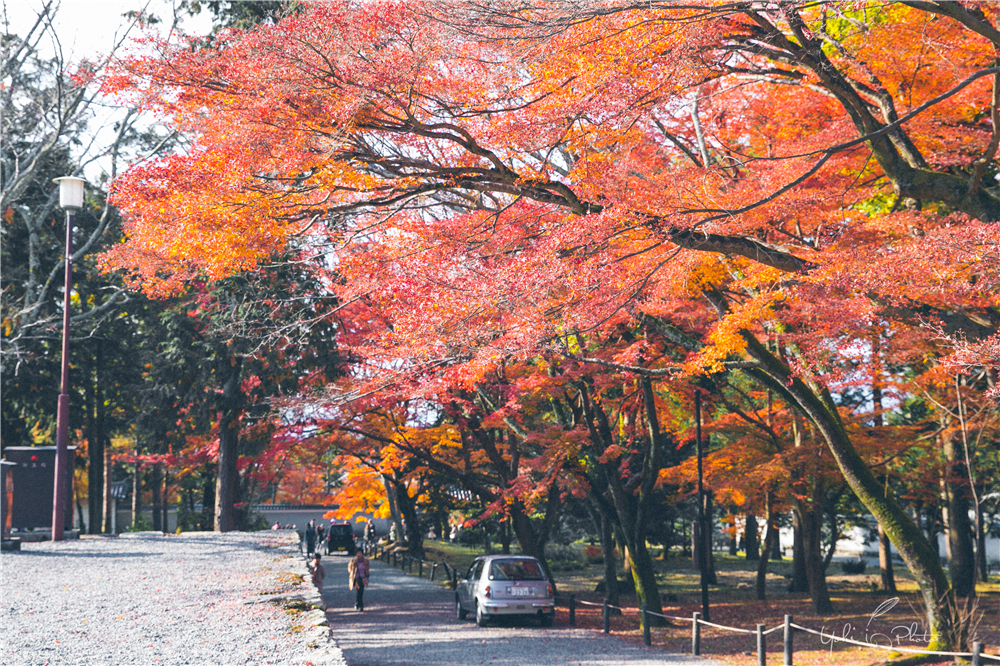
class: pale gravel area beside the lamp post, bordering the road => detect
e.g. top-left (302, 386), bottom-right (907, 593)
top-left (0, 532), bottom-right (308, 666)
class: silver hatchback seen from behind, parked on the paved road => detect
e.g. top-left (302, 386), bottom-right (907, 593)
top-left (455, 555), bottom-right (556, 627)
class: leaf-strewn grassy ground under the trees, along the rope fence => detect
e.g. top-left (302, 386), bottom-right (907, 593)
top-left (400, 541), bottom-right (1000, 666)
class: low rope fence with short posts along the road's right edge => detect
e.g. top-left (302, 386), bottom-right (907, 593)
top-left (366, 545), bottom-right (1000, 666)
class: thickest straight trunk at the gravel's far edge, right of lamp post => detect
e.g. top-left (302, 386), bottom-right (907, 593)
top-left (215, 358), bottom-right (243, 532)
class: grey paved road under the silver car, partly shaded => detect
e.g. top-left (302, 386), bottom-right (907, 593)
top-left (323, 555), bottom-right (722, 666)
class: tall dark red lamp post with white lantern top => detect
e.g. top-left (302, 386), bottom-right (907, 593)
top-left (52, 176), bottom-right (86, 541)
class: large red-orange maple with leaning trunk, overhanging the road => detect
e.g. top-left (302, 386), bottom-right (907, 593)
top-left (97, 0), bottom-right (1000, 648)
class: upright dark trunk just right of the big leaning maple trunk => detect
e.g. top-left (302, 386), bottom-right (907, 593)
top-left (941, 435), bottom-right (976, 597)
